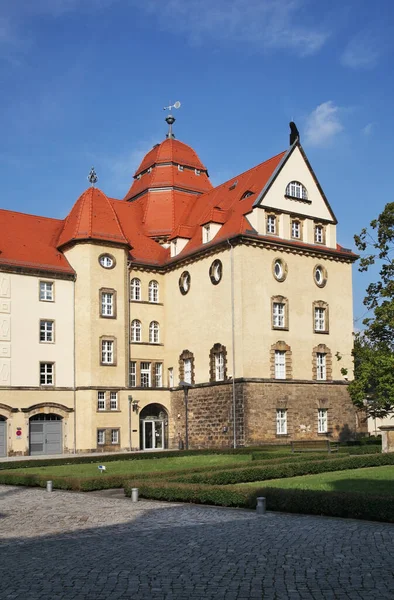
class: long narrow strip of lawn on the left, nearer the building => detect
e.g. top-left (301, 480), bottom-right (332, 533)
top-left (6, 454), bottom-right (251, 477)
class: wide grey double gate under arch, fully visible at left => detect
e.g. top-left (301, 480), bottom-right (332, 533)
top-left (29, 413), bottom-right (63, 456)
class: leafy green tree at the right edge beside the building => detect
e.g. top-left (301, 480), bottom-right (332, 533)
top-left (349, 202), bottom-right (394, 417)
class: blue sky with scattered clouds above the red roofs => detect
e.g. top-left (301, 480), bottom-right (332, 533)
top-left (0, 0), bottom-right (394, 326)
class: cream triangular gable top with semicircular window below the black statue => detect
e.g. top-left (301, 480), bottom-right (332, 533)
top-left (255, 144), bottom-right (337, 223)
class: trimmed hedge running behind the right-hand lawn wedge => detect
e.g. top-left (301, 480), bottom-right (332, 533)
top-left (174, 454), bottom-right (394, 485)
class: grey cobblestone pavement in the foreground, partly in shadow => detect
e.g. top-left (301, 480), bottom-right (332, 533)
top-left (0, 486), bottom-right (394, 600)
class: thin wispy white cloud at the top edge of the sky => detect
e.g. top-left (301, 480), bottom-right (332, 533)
top-left (132, 0), bottom-right (329, 56)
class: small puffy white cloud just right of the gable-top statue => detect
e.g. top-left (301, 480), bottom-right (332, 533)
top-left (305, 100), bottom-right (343, 146)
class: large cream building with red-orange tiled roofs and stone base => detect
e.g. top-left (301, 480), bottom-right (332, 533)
top-left (0, 115), bottom-right (362, 455)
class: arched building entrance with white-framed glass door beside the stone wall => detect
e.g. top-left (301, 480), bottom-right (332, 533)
top-left (140, 404), bottom-right (168, 450)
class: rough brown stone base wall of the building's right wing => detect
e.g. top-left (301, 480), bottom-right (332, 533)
top-left (169, 380), bottom-right (367, 448)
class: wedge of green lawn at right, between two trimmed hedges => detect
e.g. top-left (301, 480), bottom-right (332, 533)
top-left (239, 466), bottom-right (394, 496)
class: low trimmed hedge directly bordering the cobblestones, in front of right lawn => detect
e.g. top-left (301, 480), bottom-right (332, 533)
top-left (125, 481), bottom-right (394, 523)
